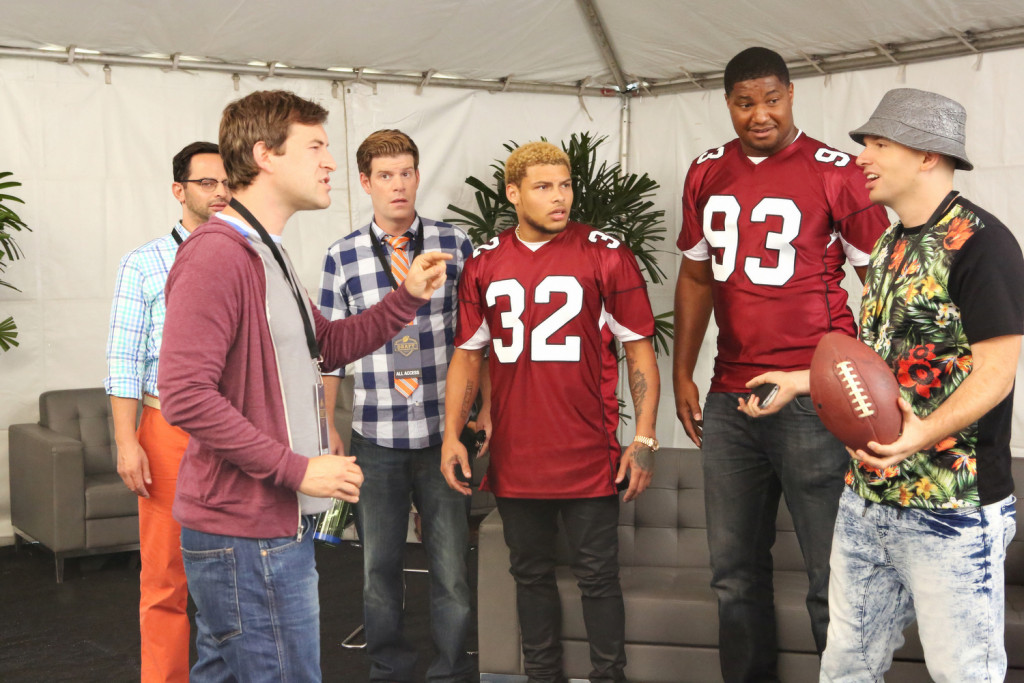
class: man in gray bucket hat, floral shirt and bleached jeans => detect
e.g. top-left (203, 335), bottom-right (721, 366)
top-left (821, 88), bottom-right (1024, 681)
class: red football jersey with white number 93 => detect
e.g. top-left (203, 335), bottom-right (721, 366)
top-left (677, 134), bottom-right (889, 392)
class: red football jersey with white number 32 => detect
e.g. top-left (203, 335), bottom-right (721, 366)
top-left (456, 223), bottom-right (654, 499)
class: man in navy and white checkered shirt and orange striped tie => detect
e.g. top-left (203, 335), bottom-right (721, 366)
top-left (319, 130), bottom-right (478, 682)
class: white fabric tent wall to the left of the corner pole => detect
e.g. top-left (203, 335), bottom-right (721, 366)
top-left (0, 58), bottom-right (620, 543)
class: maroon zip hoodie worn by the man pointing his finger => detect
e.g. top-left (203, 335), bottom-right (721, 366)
top-left (158, 217), bottom-right (426, 539)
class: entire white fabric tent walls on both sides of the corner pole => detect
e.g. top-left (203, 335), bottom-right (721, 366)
top-left (0, 50), bottom-right (1024, 543)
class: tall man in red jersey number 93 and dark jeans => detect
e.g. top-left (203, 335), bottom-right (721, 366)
top-left (673, 47), bottom-right (887, 681)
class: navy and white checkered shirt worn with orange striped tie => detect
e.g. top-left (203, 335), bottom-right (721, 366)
top-left (319, 218), bottom-right (473, 449)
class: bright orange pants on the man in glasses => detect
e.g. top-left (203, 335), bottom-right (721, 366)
top-left (138, 405), bottom-right (190, 683)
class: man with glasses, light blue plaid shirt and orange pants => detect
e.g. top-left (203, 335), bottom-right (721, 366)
top-left (105, 142), bottom-right (231, 683)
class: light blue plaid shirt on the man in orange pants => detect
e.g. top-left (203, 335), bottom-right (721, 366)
top-left (103, 222), bottom-right (188, 398)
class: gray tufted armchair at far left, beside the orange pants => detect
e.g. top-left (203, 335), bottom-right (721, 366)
top-left (8, 388), bottom-right (138, 584)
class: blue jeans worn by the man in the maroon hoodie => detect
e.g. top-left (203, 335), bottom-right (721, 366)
top-left (181, 517), bottom-right (321, 683)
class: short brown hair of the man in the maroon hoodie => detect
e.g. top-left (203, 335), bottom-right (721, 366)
top-left (219, 90), bottom-right (327, 189)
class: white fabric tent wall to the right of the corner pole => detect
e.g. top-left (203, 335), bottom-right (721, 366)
top-left (630, 50), bottom-right (1024, 456)
